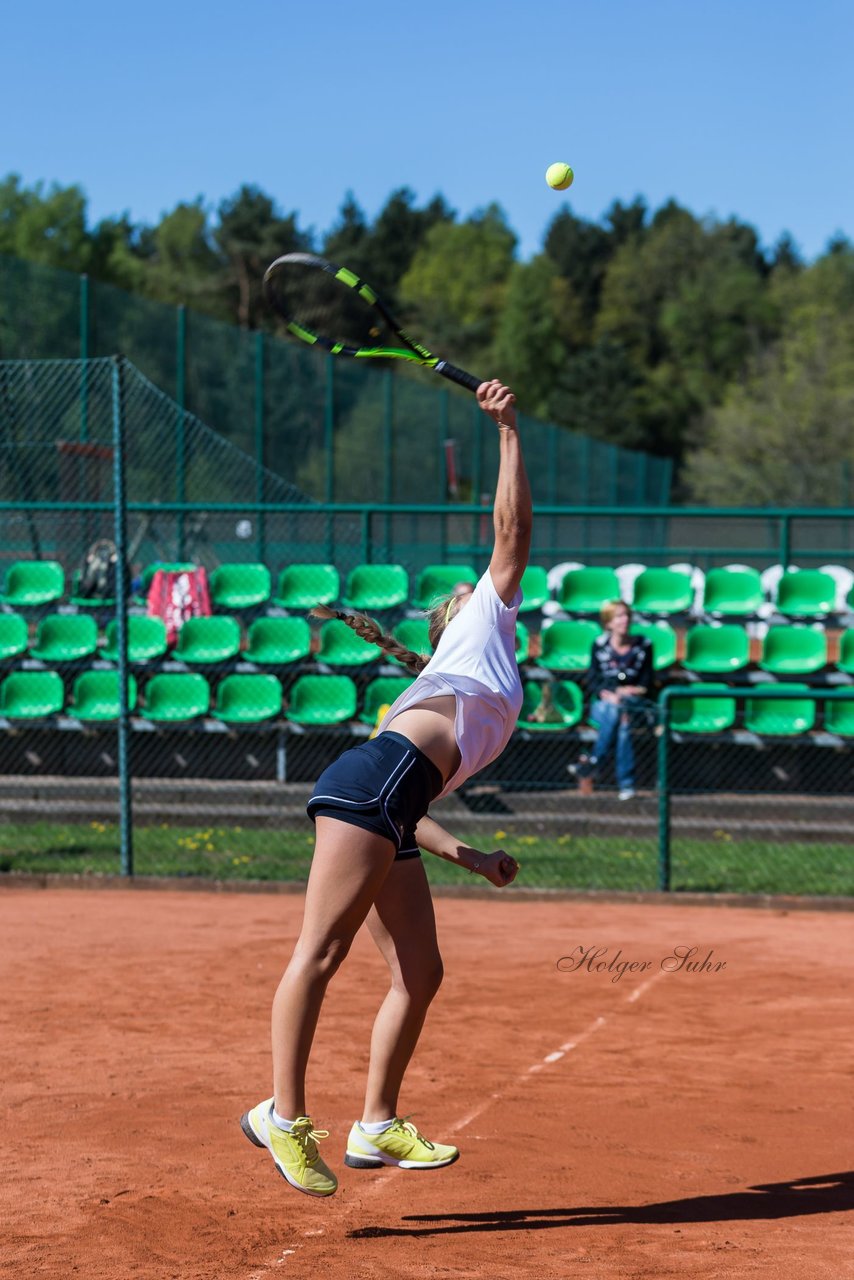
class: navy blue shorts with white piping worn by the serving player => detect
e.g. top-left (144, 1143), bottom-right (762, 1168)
top-left (306, 731), bottom-right (444, 860)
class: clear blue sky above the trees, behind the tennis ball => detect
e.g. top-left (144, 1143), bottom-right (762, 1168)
top-left (0, 0), bottom-right (854, 257)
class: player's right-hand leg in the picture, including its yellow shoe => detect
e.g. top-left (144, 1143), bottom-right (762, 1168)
top-left (344, 858), bottom-right (460, 1169)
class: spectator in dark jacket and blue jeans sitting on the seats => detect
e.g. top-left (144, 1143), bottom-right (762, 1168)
top-left (567, 600), bottom-right (653, 800)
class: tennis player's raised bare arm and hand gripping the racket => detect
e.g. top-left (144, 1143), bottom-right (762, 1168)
top-left (478, 379), bottom-right (534, 604)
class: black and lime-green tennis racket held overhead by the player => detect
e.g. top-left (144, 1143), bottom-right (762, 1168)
top-left (264, 253), bottom-right (483, 392)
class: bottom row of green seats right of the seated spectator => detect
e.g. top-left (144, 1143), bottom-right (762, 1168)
top-left (670, 684), bottom-right (854, 737)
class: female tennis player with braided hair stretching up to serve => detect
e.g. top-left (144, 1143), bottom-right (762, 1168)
top-left (241, 380), bottom-right (531, 1196)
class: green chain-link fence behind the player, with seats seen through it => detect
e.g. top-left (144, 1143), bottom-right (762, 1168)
top-left (0, 358), bottom-right (854, 893)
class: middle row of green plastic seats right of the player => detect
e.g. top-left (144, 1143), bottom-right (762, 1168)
top-left (539, 618), bottom-right (854, 676)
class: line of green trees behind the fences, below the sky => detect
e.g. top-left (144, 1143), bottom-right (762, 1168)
top-left (0, 174), bottom-right (854, 506)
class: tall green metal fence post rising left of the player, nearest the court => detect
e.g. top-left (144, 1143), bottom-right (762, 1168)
top-left (111, 356), bottom-right (133, 876)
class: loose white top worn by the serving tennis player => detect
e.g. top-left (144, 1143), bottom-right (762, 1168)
top-left (378, 570), bottom-right (522, 800)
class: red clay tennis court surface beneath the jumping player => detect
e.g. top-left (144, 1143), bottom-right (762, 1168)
top-left (0, 888), bottom-right (854, 1280)
